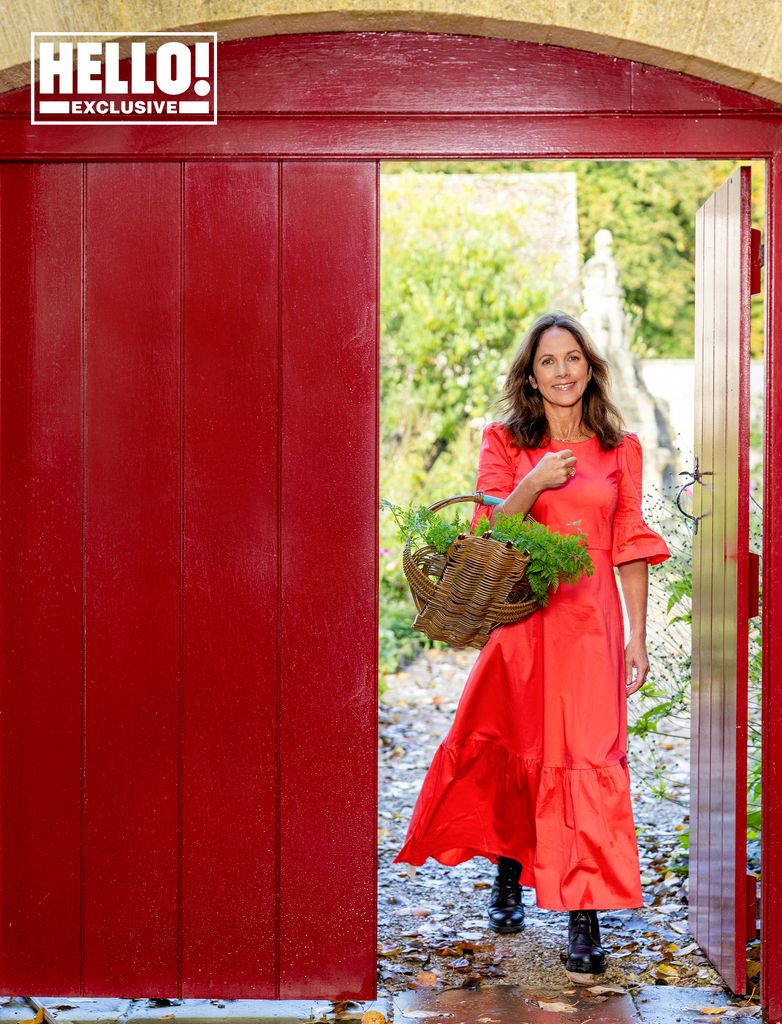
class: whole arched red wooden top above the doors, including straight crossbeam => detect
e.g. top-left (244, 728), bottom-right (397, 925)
top-left (0, 32), bottom-right (782, 160)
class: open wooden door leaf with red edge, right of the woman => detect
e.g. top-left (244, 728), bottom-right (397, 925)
top-left (689, 167), bottom-right (751, 992)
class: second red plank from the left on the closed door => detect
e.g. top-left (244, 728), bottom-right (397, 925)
top-left (83, 163), bottom-right (181, 995)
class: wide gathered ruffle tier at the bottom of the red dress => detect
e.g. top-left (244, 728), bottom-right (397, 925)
top-left (394, 737), bottom-right (644, 910)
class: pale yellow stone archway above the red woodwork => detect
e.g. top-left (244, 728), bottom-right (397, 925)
top-left (0, 0), bottom-right (782, 101)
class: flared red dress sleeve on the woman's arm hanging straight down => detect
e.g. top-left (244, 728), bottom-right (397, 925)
top-left (611, 433), bottom-right (670, 565)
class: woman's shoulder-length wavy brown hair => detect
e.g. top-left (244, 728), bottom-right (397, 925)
top-left (498, 309), bottom-right (624, 450)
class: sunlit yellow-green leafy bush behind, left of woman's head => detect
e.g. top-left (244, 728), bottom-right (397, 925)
top-left (380, 175), bottom-right (550, 489)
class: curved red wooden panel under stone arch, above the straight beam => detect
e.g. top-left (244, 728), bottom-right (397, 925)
top-left (0, 32), bottom-right (778, 117)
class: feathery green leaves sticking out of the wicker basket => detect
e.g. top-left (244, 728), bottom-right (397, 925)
top-left (380, 499), bottom-right (595, 606)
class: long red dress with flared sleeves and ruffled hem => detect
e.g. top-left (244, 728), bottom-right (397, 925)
top-left (394, 423), bottom-right (670, 910)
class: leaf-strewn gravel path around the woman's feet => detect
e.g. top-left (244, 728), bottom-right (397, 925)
top-left (379, 649), bottom-right (759, 1004)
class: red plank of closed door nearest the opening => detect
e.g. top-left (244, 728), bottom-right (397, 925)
top-left (279, 162), bottom-right (378, 998)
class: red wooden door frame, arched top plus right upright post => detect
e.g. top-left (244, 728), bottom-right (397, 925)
top-left (0, 32), bottom-right (782, 1021)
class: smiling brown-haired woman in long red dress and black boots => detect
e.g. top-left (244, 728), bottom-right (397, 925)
top-left (395, 312), bottom-right (670, 983)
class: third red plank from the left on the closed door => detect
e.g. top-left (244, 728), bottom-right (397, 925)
top-left (181, 162), bottom-right (279, 998)
